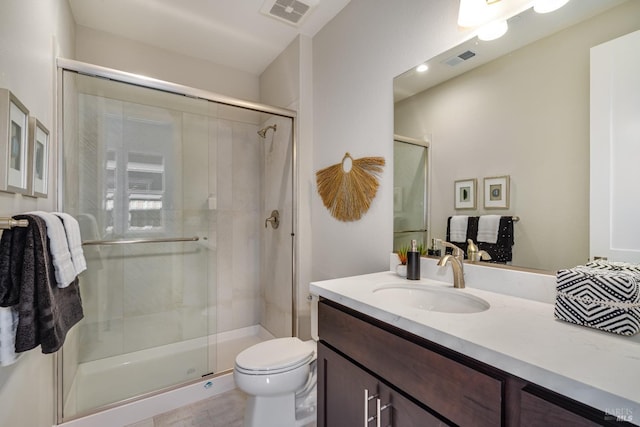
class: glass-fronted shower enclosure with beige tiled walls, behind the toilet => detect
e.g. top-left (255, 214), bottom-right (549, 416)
top-left (57, 60), bottom-right (295, 422)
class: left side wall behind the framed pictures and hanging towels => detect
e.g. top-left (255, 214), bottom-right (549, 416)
top-left (0, 0), bottom-right (74, 427)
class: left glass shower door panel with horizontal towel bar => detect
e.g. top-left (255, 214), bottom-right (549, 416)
top-left (62, 71), bottom-right (215, 418)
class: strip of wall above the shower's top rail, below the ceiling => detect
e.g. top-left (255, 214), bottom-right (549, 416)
top-left (76, 26), bottom-right (260, 101)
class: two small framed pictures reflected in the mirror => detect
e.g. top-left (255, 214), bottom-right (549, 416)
top-left (454, 175), bottom-right (509, 209)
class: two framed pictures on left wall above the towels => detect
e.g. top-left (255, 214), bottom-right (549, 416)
top-left (0, 89), bottom-right (49, 197)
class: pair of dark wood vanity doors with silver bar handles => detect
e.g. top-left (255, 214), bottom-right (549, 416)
top-left (318, 343), bottom-right (447, 427)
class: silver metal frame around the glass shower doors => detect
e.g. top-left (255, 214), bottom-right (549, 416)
top-left (54, 58), bottom-right (298, 423)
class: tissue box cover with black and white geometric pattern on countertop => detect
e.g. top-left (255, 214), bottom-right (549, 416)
top-left (554, 262), bottom-right (640, 335)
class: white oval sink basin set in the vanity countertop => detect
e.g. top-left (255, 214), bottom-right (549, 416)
top-left (373, 283), bottom-right (490, 313)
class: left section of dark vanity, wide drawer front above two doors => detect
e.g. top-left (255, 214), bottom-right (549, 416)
top-left (318, 301), bottom-right (502, 427)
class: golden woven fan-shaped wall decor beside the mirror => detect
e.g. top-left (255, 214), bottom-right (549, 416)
top-left (316, 153), bottom-right (384, 222)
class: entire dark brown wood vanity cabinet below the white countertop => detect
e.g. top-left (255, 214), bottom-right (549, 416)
top-left (318, 300), bottom-right (633, 427)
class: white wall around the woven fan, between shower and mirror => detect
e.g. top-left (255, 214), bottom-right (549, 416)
top-left (310, 0), bottom-right (465, 280)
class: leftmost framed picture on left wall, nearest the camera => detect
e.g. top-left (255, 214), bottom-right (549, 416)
top-left (0, 89), bottom-right (30, 194)
